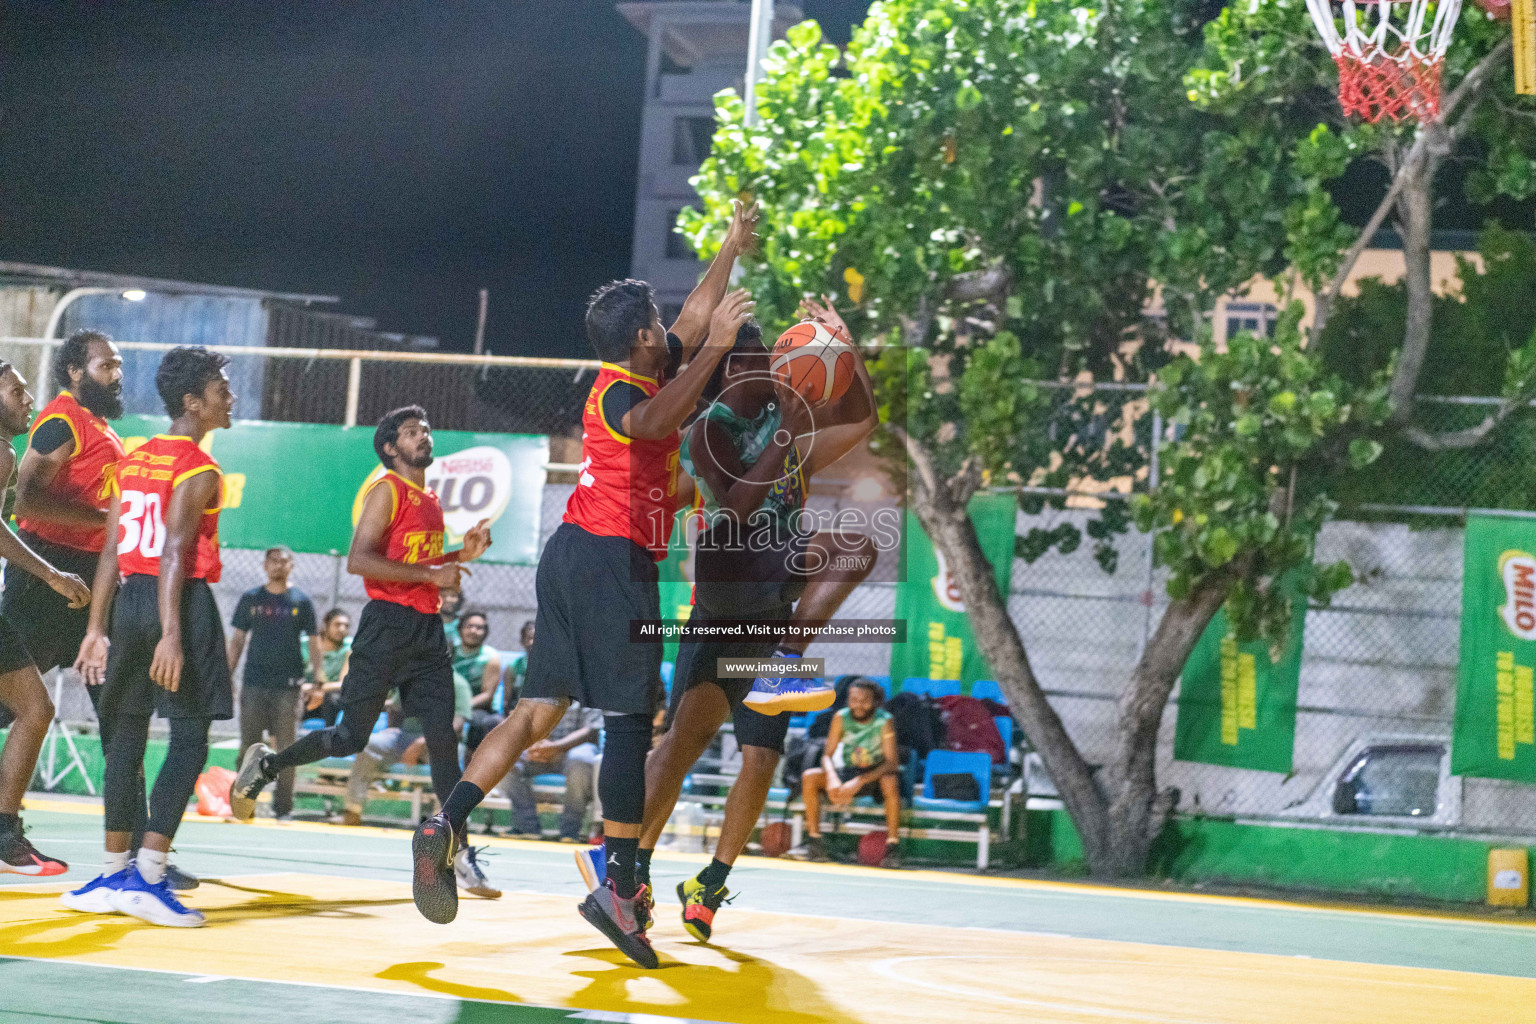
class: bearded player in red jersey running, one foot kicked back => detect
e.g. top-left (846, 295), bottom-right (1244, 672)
top-left (229, 405), bottom-right (501, 898)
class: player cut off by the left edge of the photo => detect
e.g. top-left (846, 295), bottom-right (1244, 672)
top-left (0, 359), bottom-right (91, 875)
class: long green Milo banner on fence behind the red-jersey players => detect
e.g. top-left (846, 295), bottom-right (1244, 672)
top-left (97, 416), bottom-right (550, 565)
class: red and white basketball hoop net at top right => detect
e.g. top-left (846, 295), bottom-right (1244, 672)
top-left (1307, 0), bottom-right (1461, 123)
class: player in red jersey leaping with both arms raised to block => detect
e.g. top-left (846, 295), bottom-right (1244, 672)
top-left (413, 206), bottom-right (756, 967)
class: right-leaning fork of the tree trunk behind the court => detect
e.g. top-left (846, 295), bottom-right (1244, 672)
top-left (1095, 567), bottom-right (1241, 877)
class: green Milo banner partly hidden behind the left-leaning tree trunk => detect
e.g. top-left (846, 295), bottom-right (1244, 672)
top-left (891, 494), bottom-right (1018, 688)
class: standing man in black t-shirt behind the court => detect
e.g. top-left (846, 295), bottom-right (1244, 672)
top-left (229, 548), bottom-right (326, 818)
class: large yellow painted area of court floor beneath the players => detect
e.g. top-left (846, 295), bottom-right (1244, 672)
top-left (0, 874), bottom-right (1536, 1024)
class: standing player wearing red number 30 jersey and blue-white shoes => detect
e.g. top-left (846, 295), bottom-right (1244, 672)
top-left (63, 347), bottom-right (235, 927)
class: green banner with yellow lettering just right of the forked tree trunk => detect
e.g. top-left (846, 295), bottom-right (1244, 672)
top-left (1174, 577), bottom-right (1307, 772)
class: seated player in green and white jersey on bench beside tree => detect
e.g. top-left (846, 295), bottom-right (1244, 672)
top-left (802, 679), bottom-right (902, 867)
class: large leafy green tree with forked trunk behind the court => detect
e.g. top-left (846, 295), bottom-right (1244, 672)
top-left (680, 0), bottom-right (1536, 875)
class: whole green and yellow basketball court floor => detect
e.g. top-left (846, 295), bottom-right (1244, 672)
top-left (0, 798), bottom-right (1536, 1024)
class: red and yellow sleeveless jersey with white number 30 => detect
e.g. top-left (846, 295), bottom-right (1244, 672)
top-left (115, 434), bottom-right (223, 583)
